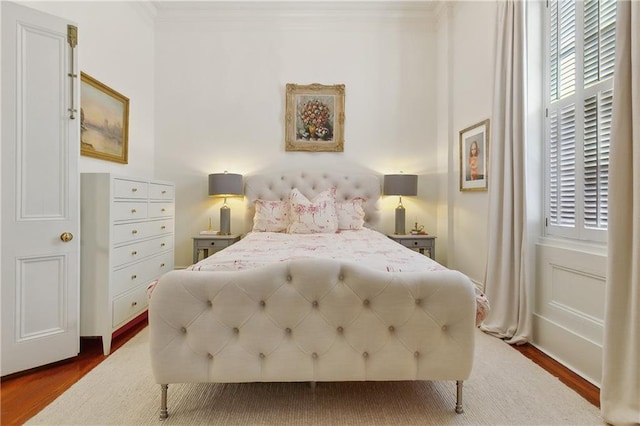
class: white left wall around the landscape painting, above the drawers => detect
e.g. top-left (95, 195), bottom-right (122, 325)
top-left (20, 1), bottom-right (155, 177)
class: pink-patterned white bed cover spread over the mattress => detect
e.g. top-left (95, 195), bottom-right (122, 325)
top-left (187, 228), bottom-right (489, 325)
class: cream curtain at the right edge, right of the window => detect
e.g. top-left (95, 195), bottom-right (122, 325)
top-left (600, 1), bottom-right (640, 425)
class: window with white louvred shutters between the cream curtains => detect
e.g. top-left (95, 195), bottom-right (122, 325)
top-left (545, 0), bottom-right (616, 241)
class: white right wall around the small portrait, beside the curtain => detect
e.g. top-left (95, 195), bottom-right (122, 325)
top-left (438, 1), bottom-right (496, 286)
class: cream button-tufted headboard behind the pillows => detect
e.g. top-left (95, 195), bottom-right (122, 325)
top-left (244, 171), bottom-right (381, 229)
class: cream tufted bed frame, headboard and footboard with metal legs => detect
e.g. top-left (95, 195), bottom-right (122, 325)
top-left (149, 172), bottom-right (475, 419)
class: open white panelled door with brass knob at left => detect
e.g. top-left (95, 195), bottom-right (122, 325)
top-left (0, 2), bottom-right (80, 376)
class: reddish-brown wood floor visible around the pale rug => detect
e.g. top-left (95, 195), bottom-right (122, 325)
top-left (0, 322), bottom-right (600, 425)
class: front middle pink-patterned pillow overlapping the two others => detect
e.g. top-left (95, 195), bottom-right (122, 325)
top-left (287, 188), bottom-right (338, 234)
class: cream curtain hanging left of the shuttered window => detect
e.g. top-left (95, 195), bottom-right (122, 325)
top-left (481, 0), bottom-right (531, 344)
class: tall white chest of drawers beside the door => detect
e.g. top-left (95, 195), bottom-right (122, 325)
top-left (80, 173), bottom-right (175, 355)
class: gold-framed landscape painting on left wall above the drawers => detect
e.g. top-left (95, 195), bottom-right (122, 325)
top-left (80, 72), bottom-right (129, 164)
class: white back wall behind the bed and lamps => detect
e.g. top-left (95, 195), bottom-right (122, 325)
top-left (156, 3), bottom-right (437, 266)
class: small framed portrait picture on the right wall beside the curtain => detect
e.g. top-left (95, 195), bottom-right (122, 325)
top-left (460, 119), bottom-right (489, 191)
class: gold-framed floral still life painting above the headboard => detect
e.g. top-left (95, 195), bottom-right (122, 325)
top-left (285, 83), bottom-right (344, 152)
